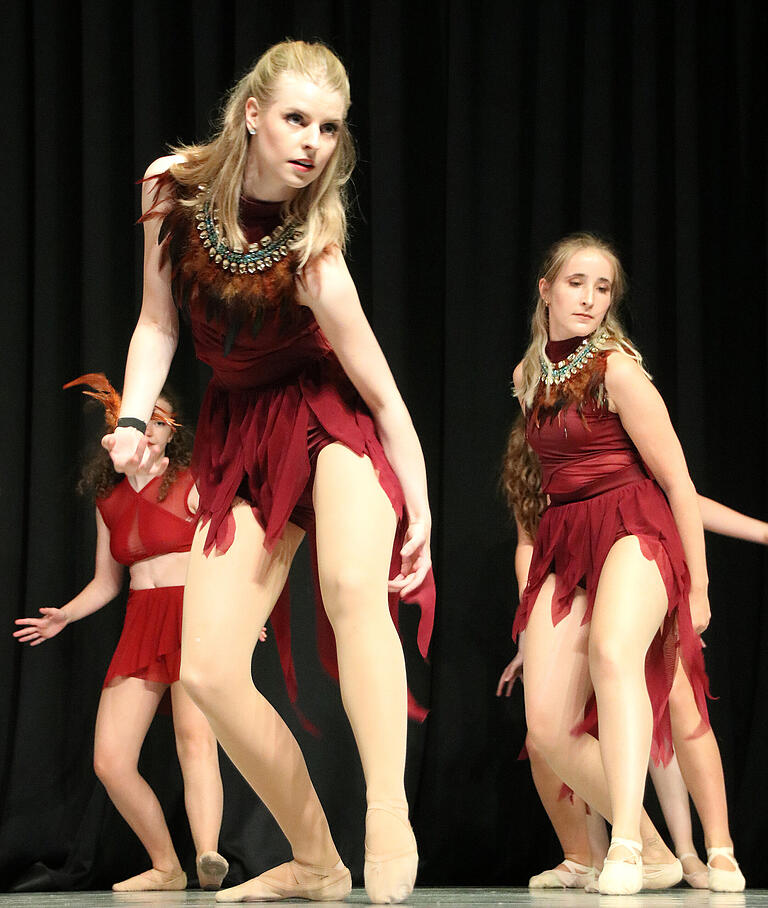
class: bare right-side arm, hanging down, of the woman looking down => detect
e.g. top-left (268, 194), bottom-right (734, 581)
top-left (605, 353), bottom-right (709, 632)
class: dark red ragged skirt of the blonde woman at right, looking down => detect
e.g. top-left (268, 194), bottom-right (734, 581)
top-left (512, 479), bottom-right (709, 765)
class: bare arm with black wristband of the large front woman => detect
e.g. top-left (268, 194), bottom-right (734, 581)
top-left (103, 157), bottom-right (179, 473)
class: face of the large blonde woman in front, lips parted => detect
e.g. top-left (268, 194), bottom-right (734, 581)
top-left (245, 73), bottom-right (344, 201)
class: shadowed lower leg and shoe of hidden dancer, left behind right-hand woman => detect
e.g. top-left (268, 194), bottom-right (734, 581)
top-left (527, 741), bottom-right (602, 889)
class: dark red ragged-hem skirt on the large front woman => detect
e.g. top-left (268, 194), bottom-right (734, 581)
top-left (192, 355), bottom-right (435, 719)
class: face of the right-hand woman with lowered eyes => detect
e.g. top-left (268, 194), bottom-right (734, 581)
top-left (539, 249), bottom-right (614, 340)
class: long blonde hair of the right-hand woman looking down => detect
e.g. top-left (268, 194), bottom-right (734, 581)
top-left (515, 233), bottom-right (650, 409)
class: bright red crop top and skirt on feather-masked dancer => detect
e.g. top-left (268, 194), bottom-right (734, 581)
top-left (96, 470), bottom-right (197, 687)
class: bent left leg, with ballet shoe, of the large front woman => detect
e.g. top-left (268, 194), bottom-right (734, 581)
top-left (181, 502), bottom-right (350, 901)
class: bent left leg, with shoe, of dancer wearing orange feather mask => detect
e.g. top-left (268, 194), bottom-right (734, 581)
top-left (93, 677), bottom-right (187, 891)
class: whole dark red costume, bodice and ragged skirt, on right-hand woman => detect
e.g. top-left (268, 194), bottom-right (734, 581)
top-left (513, 338), bottom-right (708, 764)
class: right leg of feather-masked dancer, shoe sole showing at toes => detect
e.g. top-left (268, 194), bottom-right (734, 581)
top-left (171, 682), bottom-right (229, 889)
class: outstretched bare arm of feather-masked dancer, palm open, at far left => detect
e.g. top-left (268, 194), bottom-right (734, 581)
top-left (13, 510), bottom-right (123, 646)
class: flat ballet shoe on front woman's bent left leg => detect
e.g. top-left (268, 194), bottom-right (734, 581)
top-left (216, 860), bottom-right (352, 902)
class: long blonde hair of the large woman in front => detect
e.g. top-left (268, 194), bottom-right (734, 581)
top-left (170, 41), bottom-right (355, 267)
